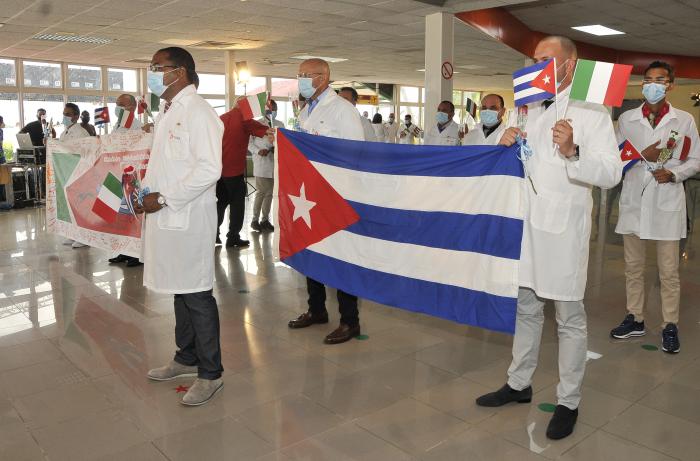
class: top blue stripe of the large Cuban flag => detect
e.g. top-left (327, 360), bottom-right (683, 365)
top-left (279, 128), bottom-right (523, 178)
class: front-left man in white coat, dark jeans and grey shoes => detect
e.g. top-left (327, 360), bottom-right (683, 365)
top-left (138, 47), bottom-right (224, 406)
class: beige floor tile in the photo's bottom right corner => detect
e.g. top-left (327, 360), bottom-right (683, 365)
top-left (603, 405), bottom-right (700, 460)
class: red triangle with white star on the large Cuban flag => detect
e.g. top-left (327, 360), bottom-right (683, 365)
top-left (277, 131), bottom-right (360, 260)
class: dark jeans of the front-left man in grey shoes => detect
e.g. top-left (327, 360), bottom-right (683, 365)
top-left (175, 290), bottom-right (224, 379)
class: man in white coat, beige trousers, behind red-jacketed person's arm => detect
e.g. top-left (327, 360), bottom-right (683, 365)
top-left (248, 99), bottom-right (284, 232)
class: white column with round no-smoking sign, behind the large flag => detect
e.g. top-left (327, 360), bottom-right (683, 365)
top-left (424, 13), bottom-right (454, 130)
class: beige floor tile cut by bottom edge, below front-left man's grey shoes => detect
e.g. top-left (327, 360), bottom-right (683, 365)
top-left (153, 418), bottom-right (273, 461)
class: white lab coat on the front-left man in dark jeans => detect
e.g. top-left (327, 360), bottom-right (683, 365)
top-left (141, 85), bottom-right (224, 294)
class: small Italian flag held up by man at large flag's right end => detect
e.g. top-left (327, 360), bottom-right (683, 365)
top-left (570, 59), bottom-right (632, 107)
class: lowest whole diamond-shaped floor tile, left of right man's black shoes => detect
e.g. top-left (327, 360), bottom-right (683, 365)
top-left (356, 398), bottom-right (469, 456)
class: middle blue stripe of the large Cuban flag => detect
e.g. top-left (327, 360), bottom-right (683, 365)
top-left (345, 201), bottom-right (523, 259)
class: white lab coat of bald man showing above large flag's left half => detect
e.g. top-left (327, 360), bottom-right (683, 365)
top-left (299, 90), bottom-right (365, 141)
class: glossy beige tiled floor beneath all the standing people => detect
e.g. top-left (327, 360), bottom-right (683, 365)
top-left (0, 185), bottom-right (700, 461)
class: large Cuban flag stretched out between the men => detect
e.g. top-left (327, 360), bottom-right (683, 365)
top-left (275, 129), bottom-right (523, 333)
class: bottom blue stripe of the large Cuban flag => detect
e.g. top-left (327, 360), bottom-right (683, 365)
top-left (284, 250), bottom-right (517, 334)
